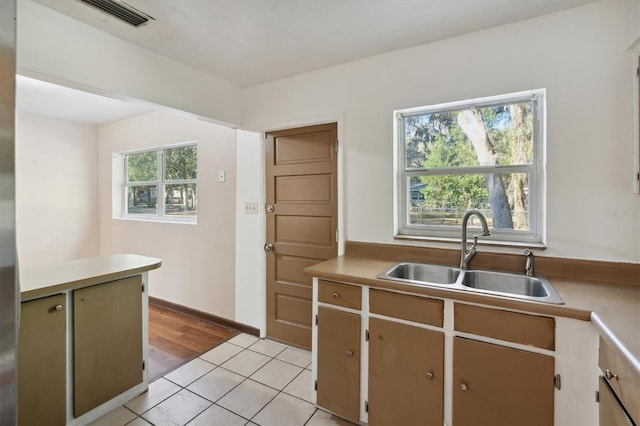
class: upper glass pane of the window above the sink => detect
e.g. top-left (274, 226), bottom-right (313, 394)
top-left (404, 102), bottom-right (534, 169)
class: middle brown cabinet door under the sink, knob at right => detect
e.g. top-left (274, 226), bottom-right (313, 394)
top-left (368, 318), bottom-right (444, 426)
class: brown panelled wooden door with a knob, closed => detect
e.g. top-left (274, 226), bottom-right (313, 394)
top-left (265, 123), bottom-right (338, 349)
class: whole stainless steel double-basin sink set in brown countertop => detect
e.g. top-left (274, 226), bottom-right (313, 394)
top-left (378, 262), bottom-right (564, 305)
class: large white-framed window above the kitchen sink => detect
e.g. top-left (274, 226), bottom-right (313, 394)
top-left (395, 90), bottom-right (545, 244)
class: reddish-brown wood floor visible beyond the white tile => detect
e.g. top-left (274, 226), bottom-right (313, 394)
top-left (149, 303), bottom-right (239, 381)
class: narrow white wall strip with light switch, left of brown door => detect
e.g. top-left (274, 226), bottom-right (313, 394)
top-left (235, 130), bottom-right (267, 331)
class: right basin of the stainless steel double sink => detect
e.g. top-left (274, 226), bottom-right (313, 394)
top-left (461, 270), bottom-right (564, 304)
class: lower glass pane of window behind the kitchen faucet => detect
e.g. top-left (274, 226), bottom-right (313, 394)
top-left (407, 173), bottom-right (529, 231)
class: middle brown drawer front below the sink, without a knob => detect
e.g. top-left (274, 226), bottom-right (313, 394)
top-left (369, 288), bottom-right (444, 327)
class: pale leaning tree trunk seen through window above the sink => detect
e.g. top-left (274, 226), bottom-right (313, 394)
top-left (458, 109), bottom-right (513, 229)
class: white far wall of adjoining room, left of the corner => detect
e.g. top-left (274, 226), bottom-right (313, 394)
top-left (16, 112), bottom-right (98, 267)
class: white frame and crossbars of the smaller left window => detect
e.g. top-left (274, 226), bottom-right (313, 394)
top-left (120, 141), bottom-right (199, 224)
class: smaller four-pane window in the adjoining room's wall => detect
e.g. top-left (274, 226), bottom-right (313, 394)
top-left (123, 144), bottom-right (198, 221)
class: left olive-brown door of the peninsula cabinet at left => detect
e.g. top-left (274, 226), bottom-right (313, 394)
top-left (18, 294), bottom-right (67, 426)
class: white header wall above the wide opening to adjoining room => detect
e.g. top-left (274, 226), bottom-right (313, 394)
top-left (17, 0), bottom-right (240, 123)
